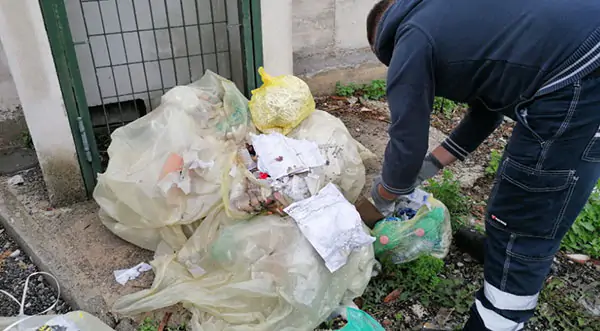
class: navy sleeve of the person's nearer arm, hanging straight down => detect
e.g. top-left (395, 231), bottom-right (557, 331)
top-left (382, 26), bottom-right (435, 195)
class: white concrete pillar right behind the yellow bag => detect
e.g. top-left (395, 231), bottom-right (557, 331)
top-left (260, 0), bottom-right (294, 76)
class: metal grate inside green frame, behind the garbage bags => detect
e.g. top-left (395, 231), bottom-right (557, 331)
top-left (64, 0), bottom-right (245, 167)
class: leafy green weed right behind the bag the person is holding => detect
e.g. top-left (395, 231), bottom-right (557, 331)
top-left (425, 170), bottom-right (471, 230)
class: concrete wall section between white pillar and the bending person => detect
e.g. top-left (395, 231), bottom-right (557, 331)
top-left (292, 0), bottom-right (385, 92)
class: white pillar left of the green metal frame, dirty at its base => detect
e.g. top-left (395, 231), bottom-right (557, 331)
top-left (0, 0), bottom-right (86, 205)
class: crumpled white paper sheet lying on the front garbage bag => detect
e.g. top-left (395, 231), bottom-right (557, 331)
top-left (284, 183), bottom-right (375, 272)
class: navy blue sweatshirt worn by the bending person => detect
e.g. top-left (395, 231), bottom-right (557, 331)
top-left (374, 0), bottom-right (600, 194)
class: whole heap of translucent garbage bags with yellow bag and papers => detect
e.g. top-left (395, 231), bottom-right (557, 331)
top-left (94, 70), bottom-right (375, 331)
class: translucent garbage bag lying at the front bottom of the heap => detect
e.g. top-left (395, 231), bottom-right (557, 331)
top-left (113, 211), bottom-right (374, 331)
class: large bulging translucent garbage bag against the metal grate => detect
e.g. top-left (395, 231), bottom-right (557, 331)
top-left (94, 71), bottom-right (254, 250)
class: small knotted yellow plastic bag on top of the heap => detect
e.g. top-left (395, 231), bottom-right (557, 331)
top-left (249, 67), bottom-right (315, 135)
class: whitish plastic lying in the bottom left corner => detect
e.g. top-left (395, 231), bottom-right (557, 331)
top-left (0, 311), bottom-right (114, 331)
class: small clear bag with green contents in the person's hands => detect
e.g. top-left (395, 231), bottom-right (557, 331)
top-left (372, 196), bottom-right (452, 264)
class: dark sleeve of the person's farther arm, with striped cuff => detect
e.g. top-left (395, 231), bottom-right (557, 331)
top-left (442, 101), bottom-right (504, 161)
